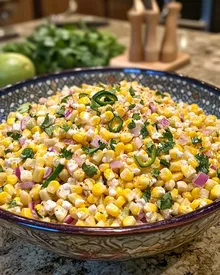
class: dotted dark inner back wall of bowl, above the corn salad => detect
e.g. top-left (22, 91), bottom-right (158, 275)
top-left (0, 68), bottom-right (220, 121)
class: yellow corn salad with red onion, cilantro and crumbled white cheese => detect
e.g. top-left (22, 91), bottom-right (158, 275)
top-left (0, 81), bottom-right (220, 227)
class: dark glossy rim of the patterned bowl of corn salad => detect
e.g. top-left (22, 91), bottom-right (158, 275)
top-left (0, 67), bottom-right (220, 236)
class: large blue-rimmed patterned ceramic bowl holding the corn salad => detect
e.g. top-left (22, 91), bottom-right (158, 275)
top-left (0, 68), bottom-right (220, 260)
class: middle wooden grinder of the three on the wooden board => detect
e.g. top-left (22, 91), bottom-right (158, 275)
top-left (144, 0), bottom-right (159, 62)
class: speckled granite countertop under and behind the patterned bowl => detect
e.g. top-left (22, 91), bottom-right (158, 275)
top-left (0, 16), bottom-right (220, 275)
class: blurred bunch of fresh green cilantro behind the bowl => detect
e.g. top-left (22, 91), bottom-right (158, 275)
top-left (2, 23), bottom-right (124, 74)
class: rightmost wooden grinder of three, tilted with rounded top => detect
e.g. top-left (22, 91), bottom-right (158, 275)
top-left (160, 2), bottom-right (182, 63)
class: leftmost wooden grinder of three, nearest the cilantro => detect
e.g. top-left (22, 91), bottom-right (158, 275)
top-left (128, 0), bottom-right (145, 62)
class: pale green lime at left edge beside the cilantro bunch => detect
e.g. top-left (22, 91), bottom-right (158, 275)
top-left (0, 53), bottom-right (35, 87)
